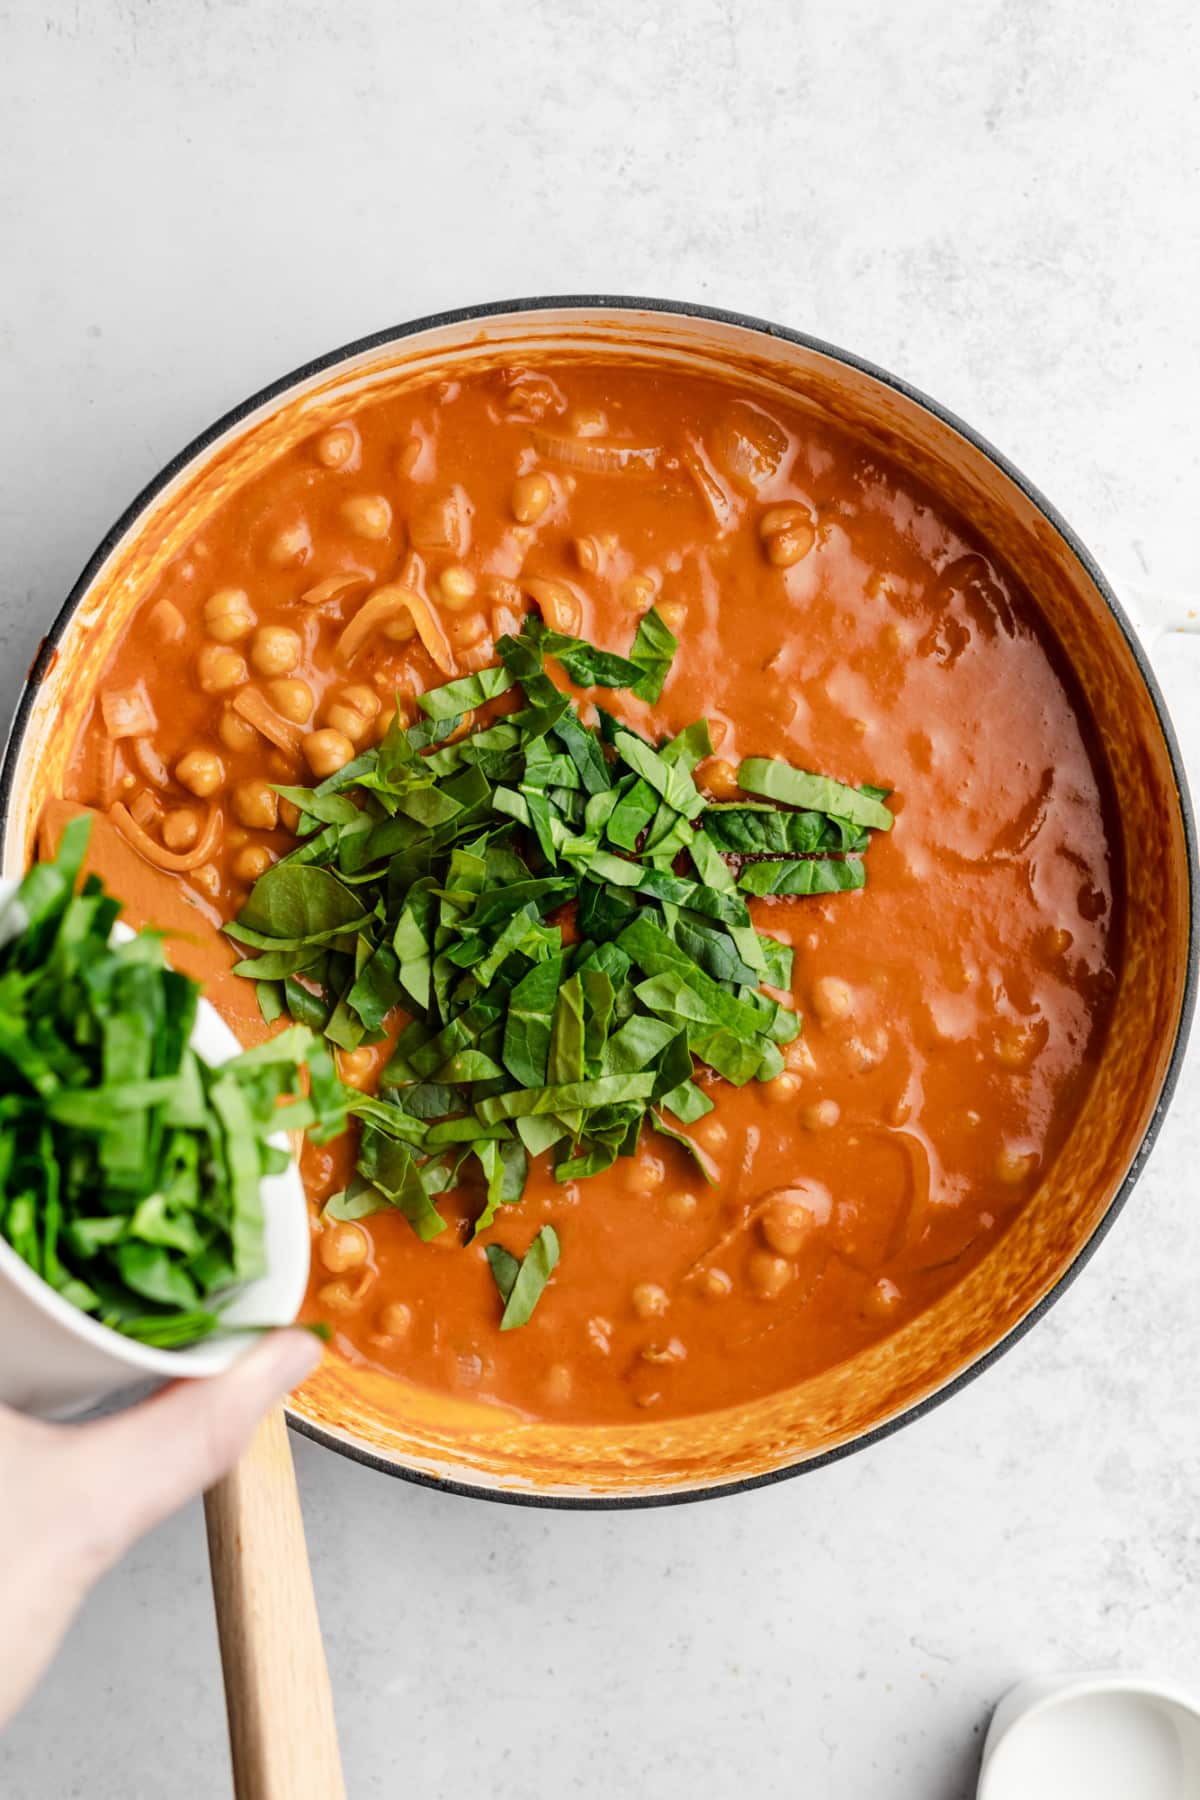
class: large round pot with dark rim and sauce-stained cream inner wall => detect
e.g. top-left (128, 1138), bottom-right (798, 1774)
top-left (0, 299), bottom-right (1200, 1507)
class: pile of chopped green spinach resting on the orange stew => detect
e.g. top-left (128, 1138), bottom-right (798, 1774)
top-left (228, 610), bottom-right (891, 1328)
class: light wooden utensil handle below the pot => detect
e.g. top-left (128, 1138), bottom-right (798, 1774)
top-left (205, 1408), bottom-right (345, 1800)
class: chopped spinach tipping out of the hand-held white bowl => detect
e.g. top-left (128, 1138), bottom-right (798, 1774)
top-left (0, 815), bottom-right (349, 1350)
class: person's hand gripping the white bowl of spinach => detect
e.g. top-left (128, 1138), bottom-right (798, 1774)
top-left (0, 1330), bottom-right (320, 1726)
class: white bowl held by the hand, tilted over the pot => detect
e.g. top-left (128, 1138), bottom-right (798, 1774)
top-left (0, 882), bottom-right (309, 1418)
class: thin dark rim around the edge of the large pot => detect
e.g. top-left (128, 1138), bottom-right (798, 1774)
top-left (0, 293), bottom-right (1200, 1512)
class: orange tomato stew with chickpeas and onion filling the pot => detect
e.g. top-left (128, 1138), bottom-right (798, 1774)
top-left (68, 364), bottom-right (1121, 1422)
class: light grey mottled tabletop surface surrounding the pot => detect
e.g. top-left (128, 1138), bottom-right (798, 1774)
top-left (0, 0), bottom-right (1200, 1800)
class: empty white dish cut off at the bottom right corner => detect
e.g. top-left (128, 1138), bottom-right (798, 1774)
top-left (979, 1672), bottom-right (1200, 1800)
